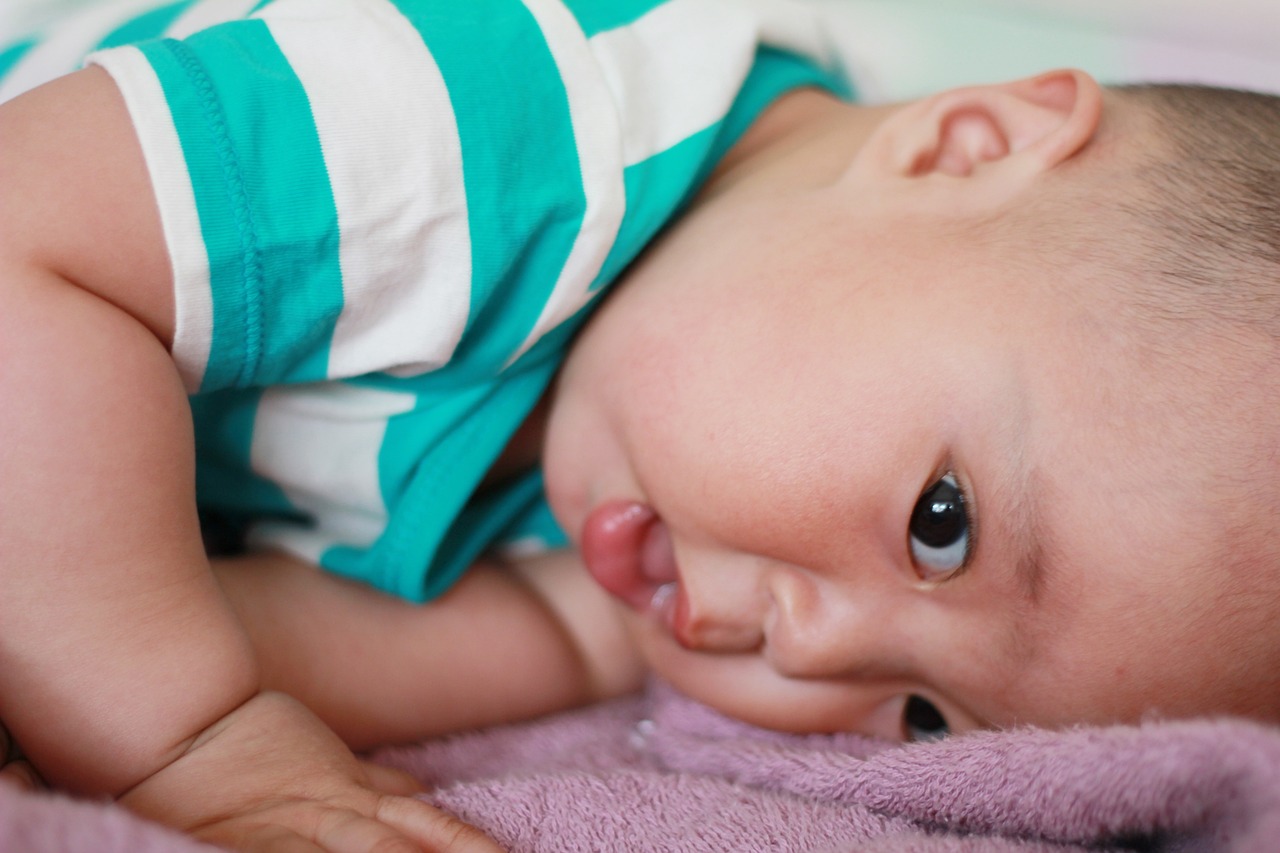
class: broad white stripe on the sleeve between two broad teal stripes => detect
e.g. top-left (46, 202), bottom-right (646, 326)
top-left (262, 0), bottom-right (471, 377)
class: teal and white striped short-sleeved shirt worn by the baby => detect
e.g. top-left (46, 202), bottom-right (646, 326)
top-left (0, 0), bottom-right (844, 601)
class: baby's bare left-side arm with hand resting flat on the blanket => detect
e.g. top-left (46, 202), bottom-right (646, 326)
top-left (0, 69), bottom-right (499, 849)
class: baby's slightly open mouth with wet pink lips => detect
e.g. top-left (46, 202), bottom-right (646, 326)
top-left (581, 501), bottom-right (681, 628)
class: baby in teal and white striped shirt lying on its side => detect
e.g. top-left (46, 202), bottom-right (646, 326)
top-left (0, 0), bottom-right (1280, 850)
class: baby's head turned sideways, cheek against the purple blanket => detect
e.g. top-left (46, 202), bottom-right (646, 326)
top-left (545, 72), bottom-right (1280, 736)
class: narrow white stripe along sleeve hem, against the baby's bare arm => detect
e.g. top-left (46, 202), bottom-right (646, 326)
top-left (87, 47), bottom-right (214, 393)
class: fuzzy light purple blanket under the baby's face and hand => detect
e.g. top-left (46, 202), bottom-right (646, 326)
top-left (0, 685), bottom-right (1280, 853)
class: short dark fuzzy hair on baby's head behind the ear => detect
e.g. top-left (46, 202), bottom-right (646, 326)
top-left (1115, 85), bottom-right (1280, 341)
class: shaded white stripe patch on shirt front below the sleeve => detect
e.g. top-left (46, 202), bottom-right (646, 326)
top-left (250, 383), bottom-right (416, 562)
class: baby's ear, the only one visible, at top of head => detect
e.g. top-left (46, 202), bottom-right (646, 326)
top-left (854, 69), bottom-right (1102, 186)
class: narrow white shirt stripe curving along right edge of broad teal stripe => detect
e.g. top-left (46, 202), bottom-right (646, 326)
top-left (508, 0), bottom-right (627, 364)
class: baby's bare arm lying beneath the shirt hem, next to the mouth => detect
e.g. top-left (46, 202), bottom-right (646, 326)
top-left (215, 552), bottom-right (643, 749)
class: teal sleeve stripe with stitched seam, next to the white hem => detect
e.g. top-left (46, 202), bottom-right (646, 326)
top-left (145, 20), bottom-right (343, 391)
